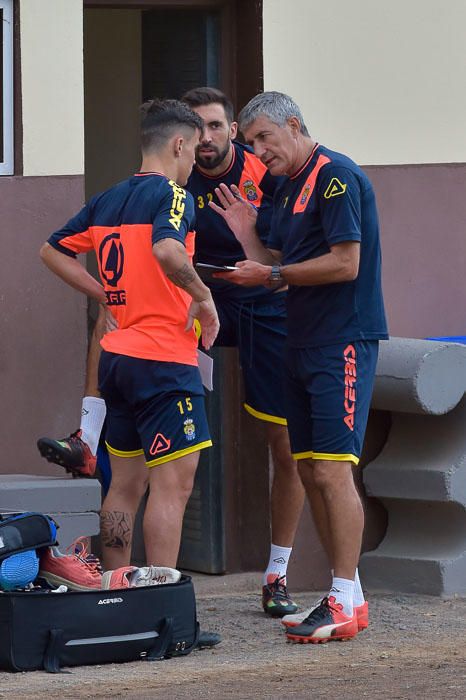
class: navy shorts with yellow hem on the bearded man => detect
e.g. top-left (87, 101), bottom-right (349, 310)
top-left (214, 292), bottom-right (286, 425)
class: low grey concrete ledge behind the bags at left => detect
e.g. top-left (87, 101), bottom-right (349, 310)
top-left (0, 474), bottom-right (101, 551)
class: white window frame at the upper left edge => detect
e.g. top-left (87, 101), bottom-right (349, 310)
top-left (0, 0), bottom-right (14, 175)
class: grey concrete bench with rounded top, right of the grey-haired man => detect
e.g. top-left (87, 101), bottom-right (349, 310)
top-left (360, 338), bottom-right (466, 596)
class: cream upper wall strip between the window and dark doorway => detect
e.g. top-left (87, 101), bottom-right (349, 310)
top-left (20, 0), bottom-right (84, 175)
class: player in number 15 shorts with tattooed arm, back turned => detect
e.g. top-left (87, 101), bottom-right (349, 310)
top-left (41, 100), bottom-right (219, 569)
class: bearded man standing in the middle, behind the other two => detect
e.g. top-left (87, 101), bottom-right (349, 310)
top-left (182, 87), bottom-right (304, 617)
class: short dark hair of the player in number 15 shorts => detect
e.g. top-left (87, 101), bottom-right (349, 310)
top-left (140, 99), bottom-right (204, 151)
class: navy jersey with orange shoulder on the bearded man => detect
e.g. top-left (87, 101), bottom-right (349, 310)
top-left (186, 141), bottom-right (283, 301)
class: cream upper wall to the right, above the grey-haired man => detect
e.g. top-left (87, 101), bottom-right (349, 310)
top-left (263, 0), bottom-right (466, 165)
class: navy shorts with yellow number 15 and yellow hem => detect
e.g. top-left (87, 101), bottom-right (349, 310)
top-left (99, 350), bottom-right (212, 467)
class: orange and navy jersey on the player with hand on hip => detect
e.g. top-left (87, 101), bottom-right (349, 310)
top-left (48, 173), bottom-right (197, 365)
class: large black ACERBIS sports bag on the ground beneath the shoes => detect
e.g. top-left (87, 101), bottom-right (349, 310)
top-left (0, 576), bottom-right (199, 673)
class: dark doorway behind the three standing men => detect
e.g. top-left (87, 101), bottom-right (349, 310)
top-left (84, 0), bottom-right (268, 573)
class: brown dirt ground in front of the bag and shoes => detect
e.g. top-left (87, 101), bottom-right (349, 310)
top-left (0, 574), bottom-right (466, 700)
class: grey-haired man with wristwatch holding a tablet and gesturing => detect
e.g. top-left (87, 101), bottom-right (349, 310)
top-left (210, 92), bottom-right (388, 643)
